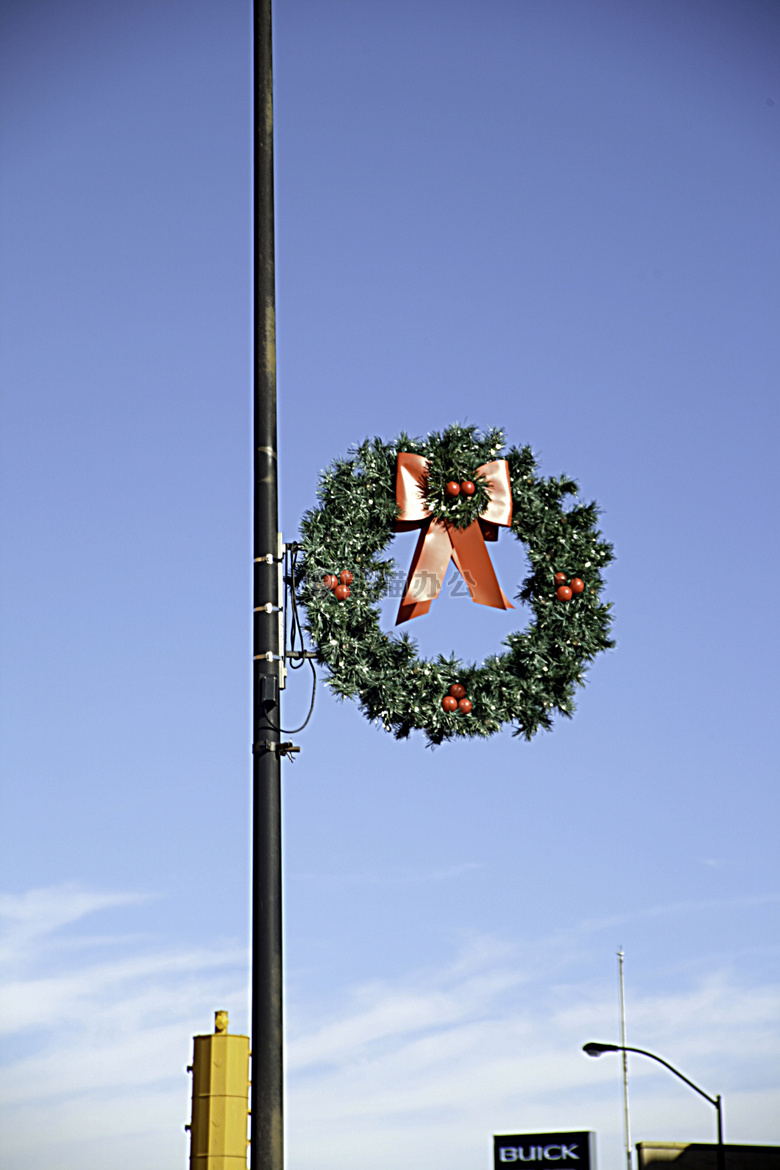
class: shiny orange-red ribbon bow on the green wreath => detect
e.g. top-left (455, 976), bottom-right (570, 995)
top-left (395, 452), bottom-right (515, 626)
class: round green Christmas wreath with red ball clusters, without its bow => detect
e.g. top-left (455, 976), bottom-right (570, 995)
top-left (296, 425), bottom-right (614, 744)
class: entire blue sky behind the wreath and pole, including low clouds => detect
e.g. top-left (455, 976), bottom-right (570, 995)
top-left (0, 0), bottom-right (780, 1170)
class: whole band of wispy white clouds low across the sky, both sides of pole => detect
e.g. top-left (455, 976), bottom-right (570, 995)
top-left (0, 887), bottom-right (780, 1170)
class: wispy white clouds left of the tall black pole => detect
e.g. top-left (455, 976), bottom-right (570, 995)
top-left (0, 886), bottom-right (247, 1170)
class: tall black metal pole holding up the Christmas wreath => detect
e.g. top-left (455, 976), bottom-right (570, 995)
top-left (250, 0), bottom-right (284, 1170)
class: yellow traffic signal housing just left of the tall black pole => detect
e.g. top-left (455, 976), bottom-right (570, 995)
top-left (187, 1012), bottom-right (249, 1170)
